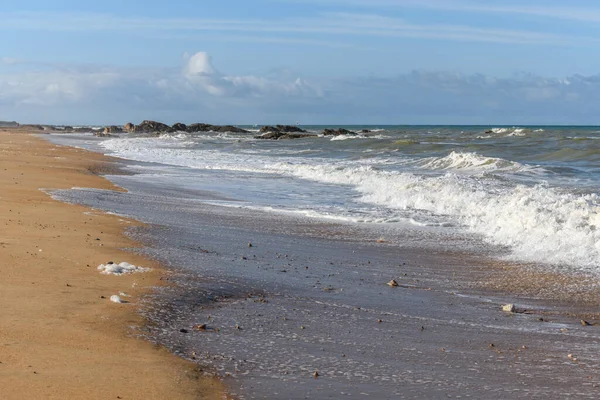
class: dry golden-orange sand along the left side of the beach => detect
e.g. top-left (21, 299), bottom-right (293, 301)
top-left (0, 129), bottom-right (227, 399)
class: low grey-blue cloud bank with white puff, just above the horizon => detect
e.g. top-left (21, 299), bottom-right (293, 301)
top-left (0, 52), bottom-right (600, 124)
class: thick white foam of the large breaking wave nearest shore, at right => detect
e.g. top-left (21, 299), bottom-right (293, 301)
top-left (278, 166), bottom-right (600, 271)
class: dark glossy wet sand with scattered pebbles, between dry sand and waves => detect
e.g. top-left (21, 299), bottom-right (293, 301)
top-left (48, 164), bottom-right (600, 399)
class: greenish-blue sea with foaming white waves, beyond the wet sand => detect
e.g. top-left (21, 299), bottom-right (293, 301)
top-left (49, 126), bottom-right (600, 274)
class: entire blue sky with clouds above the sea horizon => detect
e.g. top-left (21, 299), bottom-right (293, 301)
top-left (0, 0), bottom-right (600, 125)
